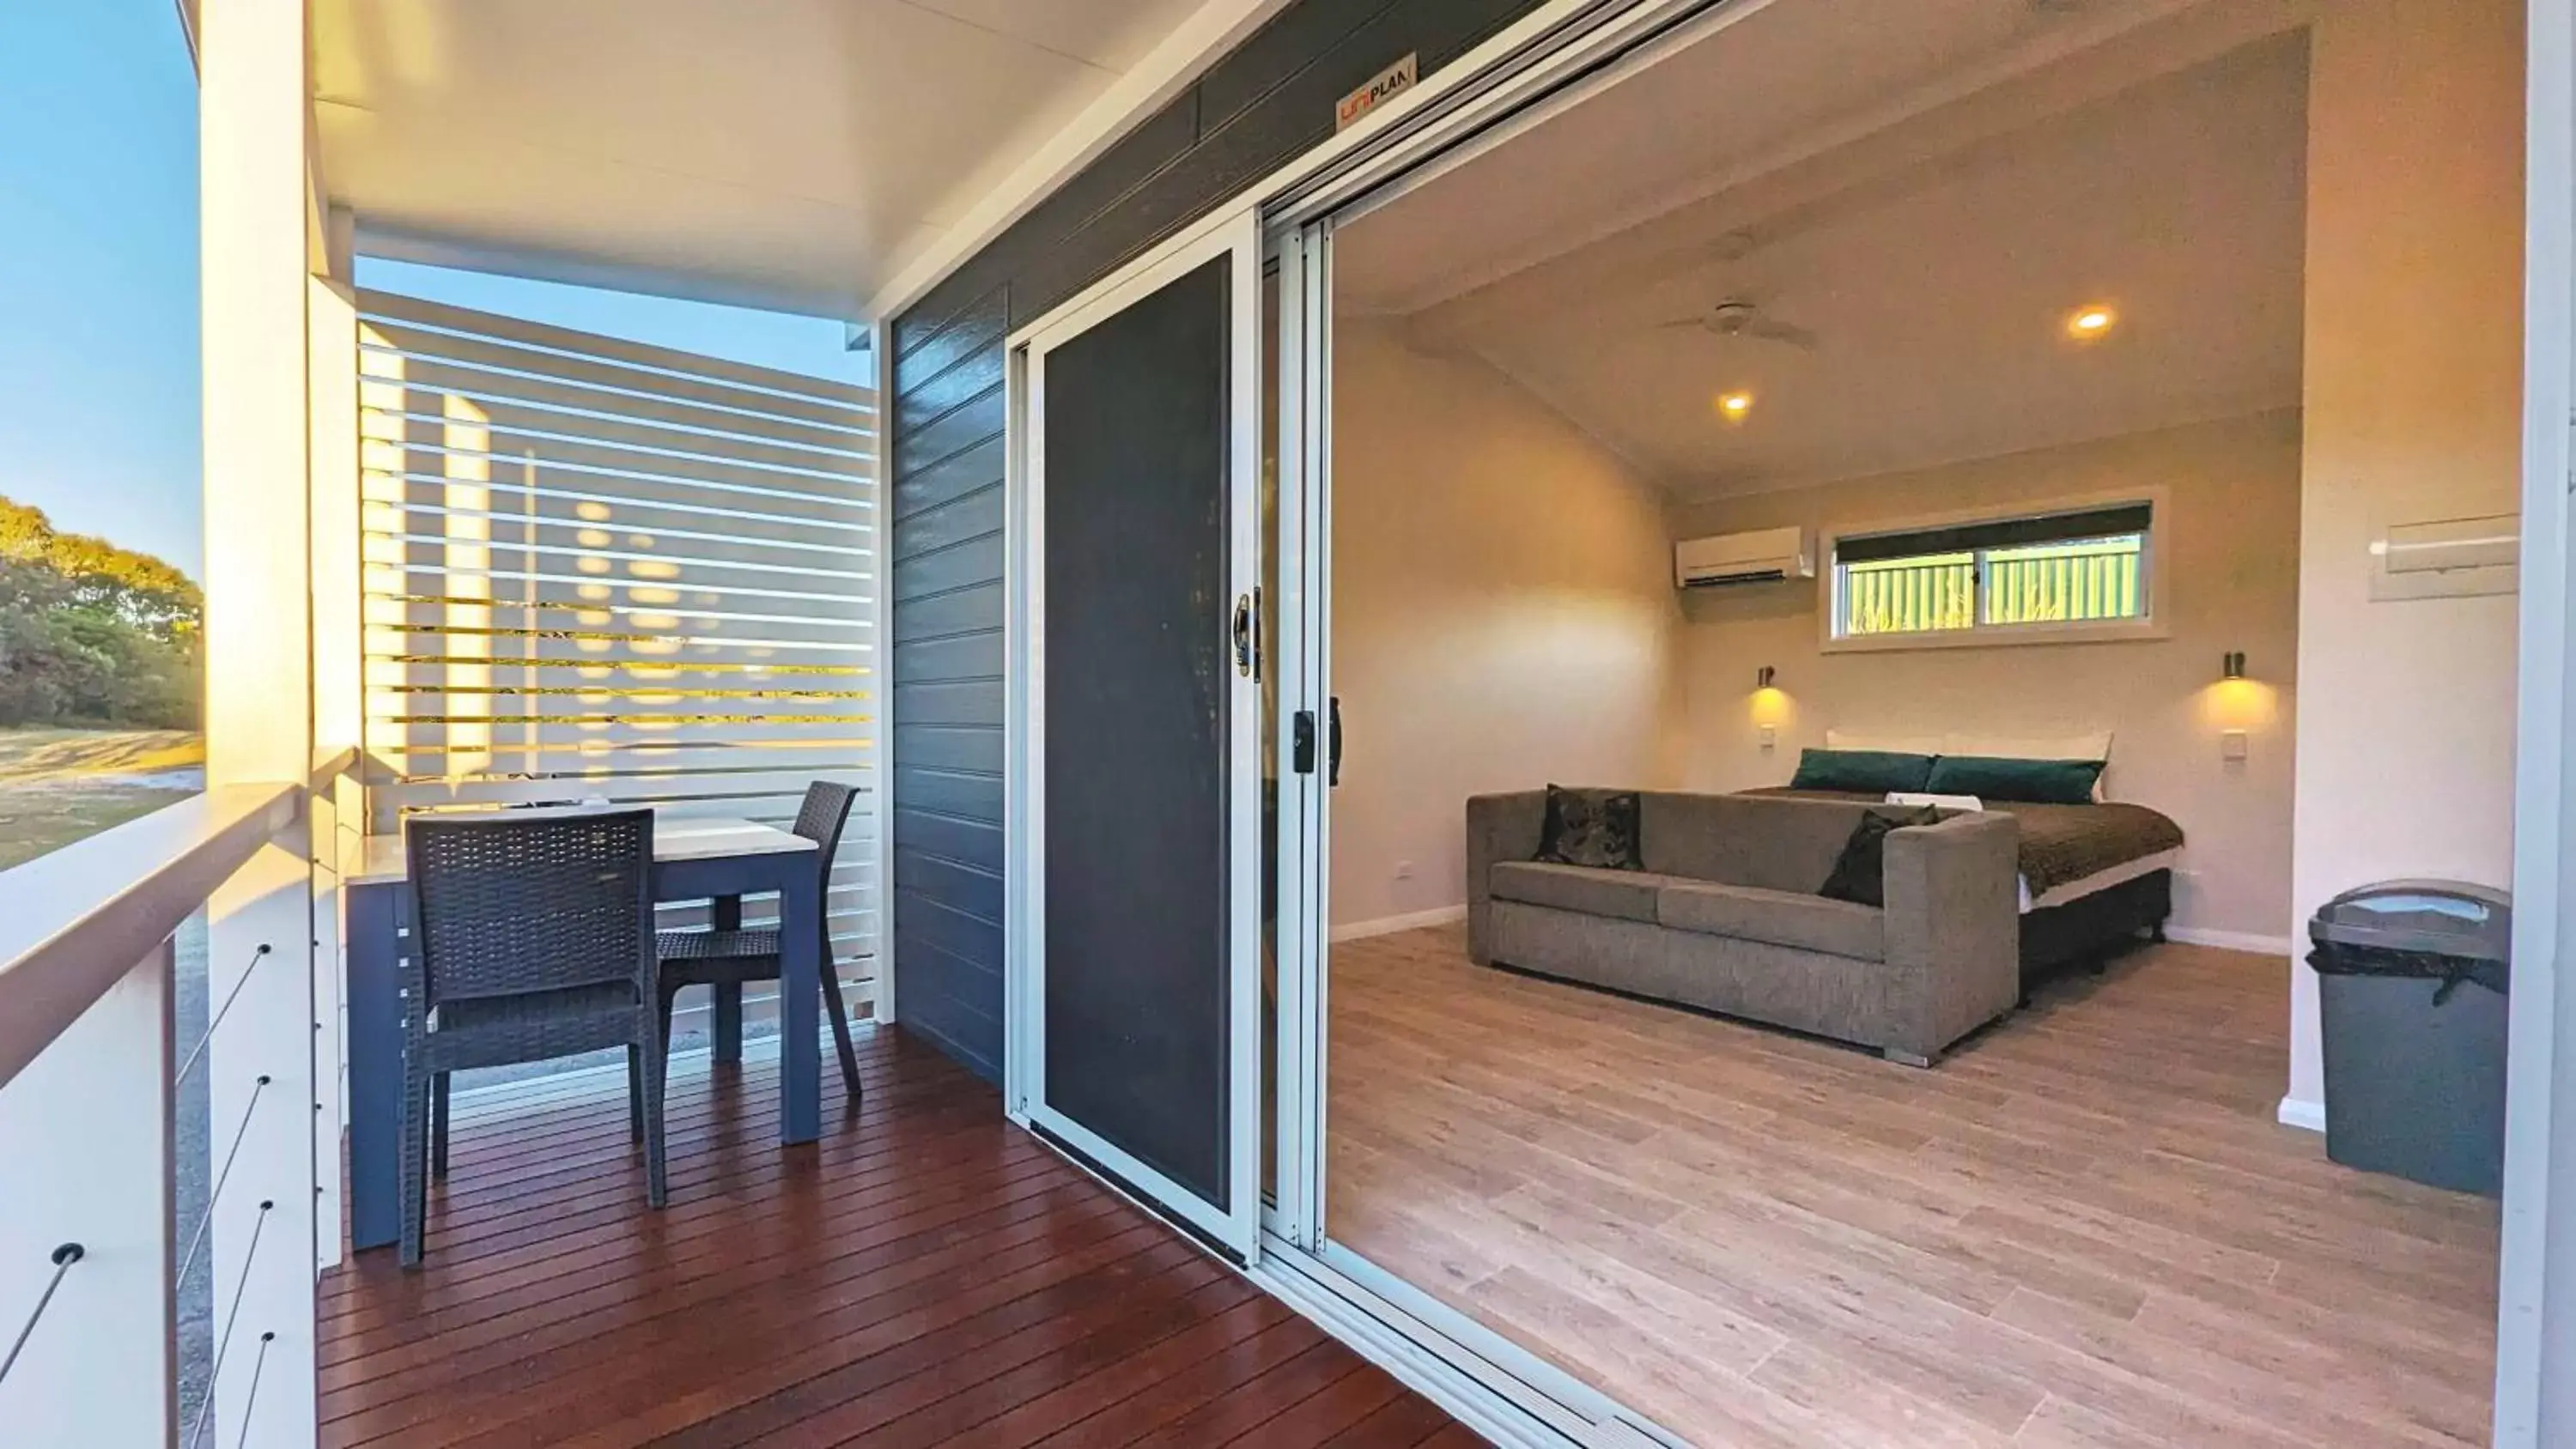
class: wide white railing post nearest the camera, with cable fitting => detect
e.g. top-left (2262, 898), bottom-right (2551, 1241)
top-left (0, 939), bottom-right (178, 1449)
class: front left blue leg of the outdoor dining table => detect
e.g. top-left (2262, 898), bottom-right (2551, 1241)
top-left (348, 885), bottom-right (410, 1248)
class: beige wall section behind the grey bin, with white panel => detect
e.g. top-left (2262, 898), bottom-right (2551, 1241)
top-left (2282, 0), bottom-right (2522, 1122)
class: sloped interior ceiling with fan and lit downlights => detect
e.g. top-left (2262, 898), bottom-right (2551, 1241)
top-left (1334, 0), bottom-right (2306, 497)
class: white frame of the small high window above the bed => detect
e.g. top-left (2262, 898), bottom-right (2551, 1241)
top-left (1816, 487), bottom-right (2174, 654)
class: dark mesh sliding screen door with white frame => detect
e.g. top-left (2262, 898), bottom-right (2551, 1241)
top-left (1023, 207), bottom-right (1260, 1256)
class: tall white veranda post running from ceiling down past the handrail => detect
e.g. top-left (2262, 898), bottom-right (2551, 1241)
top-left (202, 0), bottom-right (337, 1449)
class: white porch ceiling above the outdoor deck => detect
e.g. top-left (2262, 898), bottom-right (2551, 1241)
top-left (314, 0), bottom-right (1236, 317)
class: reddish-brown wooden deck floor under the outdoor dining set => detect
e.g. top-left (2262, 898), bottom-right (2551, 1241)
top-left (319, 1029), bottom-right (1479, 1449)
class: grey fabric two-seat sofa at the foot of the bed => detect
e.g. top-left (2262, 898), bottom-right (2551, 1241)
top-left (1466, 790), bottom-right (2022, 1065)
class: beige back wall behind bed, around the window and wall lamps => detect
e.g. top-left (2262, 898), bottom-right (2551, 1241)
top-left (1672, 412), bottom-right (2300, 939)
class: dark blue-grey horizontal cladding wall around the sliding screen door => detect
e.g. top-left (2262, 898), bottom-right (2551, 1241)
top-left (889, 0), bottom-right (1538, 1078)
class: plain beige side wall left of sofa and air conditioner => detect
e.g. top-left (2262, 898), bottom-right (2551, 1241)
top-left (1332, 322), bottom-right (1680, 926)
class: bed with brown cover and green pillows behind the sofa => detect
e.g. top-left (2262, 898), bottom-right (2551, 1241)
top-left (1747, 785), bottom-right (2182, 983)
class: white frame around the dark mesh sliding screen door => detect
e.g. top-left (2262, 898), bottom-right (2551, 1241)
top-left (1002, 206), bottom-right (1262, 1266)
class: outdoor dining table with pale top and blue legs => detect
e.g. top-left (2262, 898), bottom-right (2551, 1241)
top-left (343, 810), bottom-right (822, 1248)
